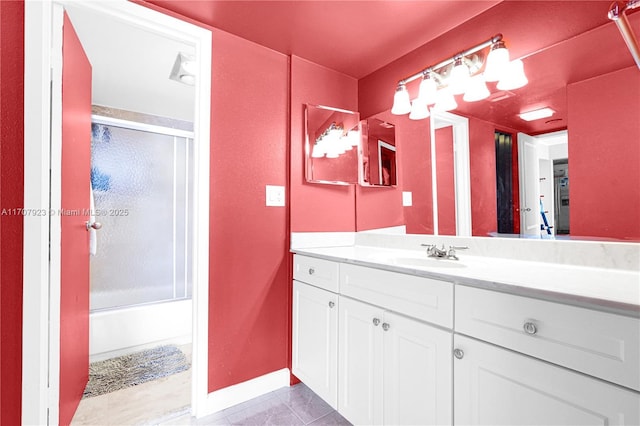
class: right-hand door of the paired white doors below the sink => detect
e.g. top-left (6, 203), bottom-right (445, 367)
top-left (382, 312), bottom-right (453, 425)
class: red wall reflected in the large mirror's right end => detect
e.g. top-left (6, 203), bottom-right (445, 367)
top-left (567, 67), bottom-right (640, 240)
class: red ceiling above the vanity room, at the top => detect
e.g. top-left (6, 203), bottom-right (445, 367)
top-left (148, 0), bottom-right (500, 78)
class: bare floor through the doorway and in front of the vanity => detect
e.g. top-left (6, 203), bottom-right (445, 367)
top-left (71, 345), bottom-right (350, 426)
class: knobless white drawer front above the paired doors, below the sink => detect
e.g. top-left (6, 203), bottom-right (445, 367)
top-left (340, 264), bottom-right (453, 328)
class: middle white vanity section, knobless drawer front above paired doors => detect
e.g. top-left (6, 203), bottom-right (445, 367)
top-left (338, 264), bottom-right (453, 425)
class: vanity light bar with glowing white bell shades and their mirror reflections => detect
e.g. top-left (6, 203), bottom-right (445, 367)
top-left (391, 33), bottom-right (528, 120)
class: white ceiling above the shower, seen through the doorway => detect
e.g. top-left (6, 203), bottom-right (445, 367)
top-left (65, 0), bottom-right (195, 122)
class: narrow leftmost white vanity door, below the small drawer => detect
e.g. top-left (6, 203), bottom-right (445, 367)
top-left (291, 281), bottom-right (338, 409)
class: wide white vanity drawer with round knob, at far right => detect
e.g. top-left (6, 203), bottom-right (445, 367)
top-left (455, 285), bottom-right (640, 390)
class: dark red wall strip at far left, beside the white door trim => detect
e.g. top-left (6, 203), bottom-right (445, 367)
top-left (0, 1), bottom-right (24, 425)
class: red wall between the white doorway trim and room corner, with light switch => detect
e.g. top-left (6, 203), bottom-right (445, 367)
top-left (209, 29), bottom-right (290, 391)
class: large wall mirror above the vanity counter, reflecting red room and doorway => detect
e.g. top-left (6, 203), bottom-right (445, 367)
top-left (358, 6), bottom-right (640, 241)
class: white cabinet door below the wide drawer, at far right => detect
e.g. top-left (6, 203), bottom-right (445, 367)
top-left (454, 335), bottom-right (640, 426)
